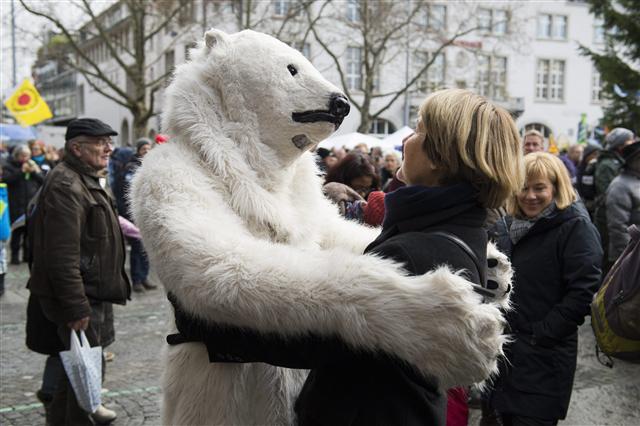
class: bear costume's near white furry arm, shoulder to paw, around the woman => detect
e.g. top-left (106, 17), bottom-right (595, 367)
top-left (133, 173), bottom-right (510, 385)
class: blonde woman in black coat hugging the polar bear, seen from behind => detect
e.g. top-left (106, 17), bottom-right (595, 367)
top-left (170, 90), bottom-right (524, 426)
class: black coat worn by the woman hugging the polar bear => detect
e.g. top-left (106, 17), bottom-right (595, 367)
top-left (167, 191), bottom-right (487, 426)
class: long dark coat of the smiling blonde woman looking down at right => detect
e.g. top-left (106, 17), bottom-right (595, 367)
top-left (491, 202), bottom-right (602, 420)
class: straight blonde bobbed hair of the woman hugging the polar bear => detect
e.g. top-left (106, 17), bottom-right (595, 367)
top-left (420, 89), bottom-right (524, 208)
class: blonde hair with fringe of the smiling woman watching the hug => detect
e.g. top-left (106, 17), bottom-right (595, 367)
top-left (507, 152), bottom-right (578, 215)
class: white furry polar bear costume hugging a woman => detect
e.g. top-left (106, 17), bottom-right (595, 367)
top-left (131, 30), bottom-right (510, 425)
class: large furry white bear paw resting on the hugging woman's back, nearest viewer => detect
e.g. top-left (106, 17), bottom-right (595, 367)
top-left (382, 267), bottom-right (507, 388)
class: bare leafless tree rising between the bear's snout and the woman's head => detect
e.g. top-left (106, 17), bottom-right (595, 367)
top-left (304, 0), bottom-right (512, 133)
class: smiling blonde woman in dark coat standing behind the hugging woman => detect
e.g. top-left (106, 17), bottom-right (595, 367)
top-left (490, 152), bottom-right (602, 426)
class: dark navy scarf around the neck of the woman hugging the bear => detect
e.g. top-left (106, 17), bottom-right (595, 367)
top-left (382, 182), bottom-right (478, 228)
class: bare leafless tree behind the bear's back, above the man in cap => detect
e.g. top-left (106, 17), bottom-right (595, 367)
top-left (20, 0), bottom-right (195, 137)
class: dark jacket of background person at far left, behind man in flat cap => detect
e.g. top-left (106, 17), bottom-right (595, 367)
top-left (2, 160), bottom-right (44, 222)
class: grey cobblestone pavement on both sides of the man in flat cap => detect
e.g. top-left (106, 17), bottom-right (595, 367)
top-left (0, 264), bottom-right (170, 426)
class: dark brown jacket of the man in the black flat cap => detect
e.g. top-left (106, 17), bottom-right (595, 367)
top-left (28, 155), bottom-right (131, 325)
